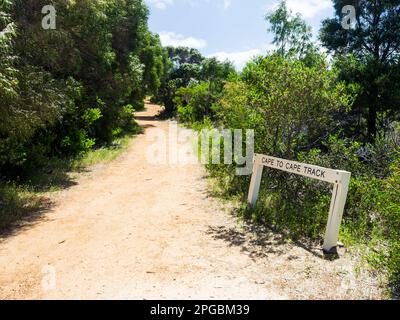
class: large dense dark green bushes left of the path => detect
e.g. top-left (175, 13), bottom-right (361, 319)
top-left (0, 0), bottom-right (164, 178)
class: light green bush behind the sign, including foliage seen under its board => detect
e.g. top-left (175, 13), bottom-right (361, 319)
top-left (211, 55), bottom-right (351, 237)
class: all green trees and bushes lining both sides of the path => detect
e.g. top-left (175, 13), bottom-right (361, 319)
top-left (0, 0), bottom-right (400, 296)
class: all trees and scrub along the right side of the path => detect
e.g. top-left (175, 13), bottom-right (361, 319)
top-left (164, 1), bottom-right (400, 294)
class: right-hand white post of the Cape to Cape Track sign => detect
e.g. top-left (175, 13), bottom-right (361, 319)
top-left (323, 173), bottom-right (351, 252)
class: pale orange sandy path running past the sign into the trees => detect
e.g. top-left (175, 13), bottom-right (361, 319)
top-left (0, 105), bottom-right (379, 299)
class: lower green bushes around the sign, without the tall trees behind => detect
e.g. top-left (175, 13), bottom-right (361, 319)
top-left (190, 55), bottom-right (400, 284)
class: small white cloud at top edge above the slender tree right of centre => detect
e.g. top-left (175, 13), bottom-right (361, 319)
top-left (267, 0), bottom-right (333, 19)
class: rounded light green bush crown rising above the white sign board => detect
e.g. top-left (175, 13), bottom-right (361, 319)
top-left (217, 55), bottom-right (351, 159)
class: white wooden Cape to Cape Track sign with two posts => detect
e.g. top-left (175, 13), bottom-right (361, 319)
top-left (248, 154), bottom-right (351, 252)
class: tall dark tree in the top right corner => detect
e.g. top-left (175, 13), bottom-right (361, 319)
top-left (320, 0), bottom-right (400, 140)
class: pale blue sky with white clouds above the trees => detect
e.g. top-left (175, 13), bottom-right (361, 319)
top-left (145, 0), bottom-right (333, 69)
